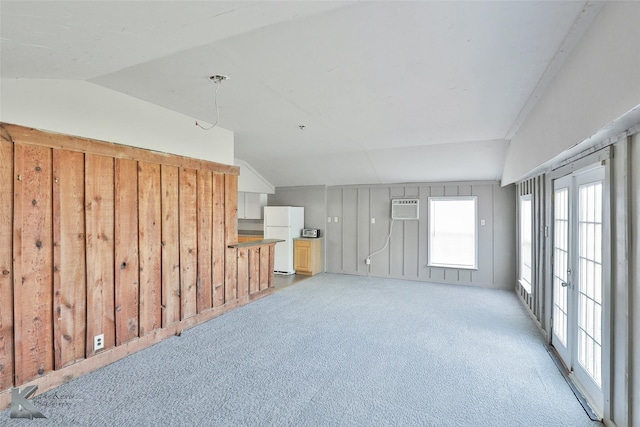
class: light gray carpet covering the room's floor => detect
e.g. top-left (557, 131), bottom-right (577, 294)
top-left (0, 274), bottom-right (600, 427)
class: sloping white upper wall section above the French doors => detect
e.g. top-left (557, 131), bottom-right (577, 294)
top-left (502, 1), bottom-right (640, 185)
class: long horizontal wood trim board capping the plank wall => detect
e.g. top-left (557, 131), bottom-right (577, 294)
top-left (0, 123), bottom-right (240, 175)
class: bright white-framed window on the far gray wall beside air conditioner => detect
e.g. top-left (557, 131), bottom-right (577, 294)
top-left (428, 196), bottom-right (478, 269)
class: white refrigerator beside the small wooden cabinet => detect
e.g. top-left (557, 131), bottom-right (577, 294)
top-left (264, 206), bottom-right (304, 274)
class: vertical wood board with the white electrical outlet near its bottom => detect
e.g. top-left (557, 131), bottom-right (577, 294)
top-left (85, 154), bottom-right (116, 357)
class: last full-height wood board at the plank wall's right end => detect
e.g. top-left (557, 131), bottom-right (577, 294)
top-left (224, 175), bottom-right (238, 303)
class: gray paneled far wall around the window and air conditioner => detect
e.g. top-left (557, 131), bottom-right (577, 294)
top-left (269, 182), bottom-right (516, 289)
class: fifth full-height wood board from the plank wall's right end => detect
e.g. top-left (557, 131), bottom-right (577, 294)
top-left (160, 165), bottom-right (180, 327)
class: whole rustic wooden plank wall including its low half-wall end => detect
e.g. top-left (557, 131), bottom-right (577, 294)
top-left (0, 124), bottom-right (284, 409)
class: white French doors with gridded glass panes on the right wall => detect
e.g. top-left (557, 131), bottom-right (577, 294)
top-left (551, 166), bottom-right (604, 414)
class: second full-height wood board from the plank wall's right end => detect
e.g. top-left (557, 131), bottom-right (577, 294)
top-left (211, 173), bottom-right (226, 307)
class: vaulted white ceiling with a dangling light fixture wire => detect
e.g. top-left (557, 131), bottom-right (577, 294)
top-left (0, 1), bottom-right (587, 186)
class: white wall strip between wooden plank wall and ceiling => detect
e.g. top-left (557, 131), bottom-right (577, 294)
top-left (0, 79), bottom-right (234, 165)
